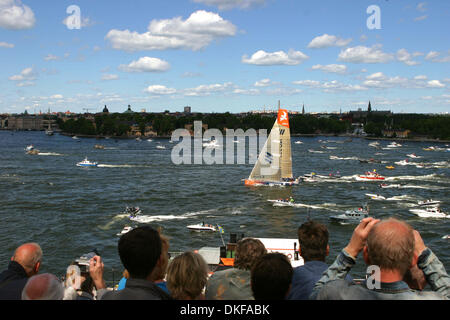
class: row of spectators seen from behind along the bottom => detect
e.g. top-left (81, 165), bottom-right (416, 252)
top-left (0, 218), bottom-right (450, 300)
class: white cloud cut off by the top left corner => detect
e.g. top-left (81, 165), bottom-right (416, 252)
top-left (0, 0), bottom-right (36, 30)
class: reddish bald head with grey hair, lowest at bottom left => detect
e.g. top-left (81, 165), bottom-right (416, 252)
top-left (22, 273), bottom-right (64, 300)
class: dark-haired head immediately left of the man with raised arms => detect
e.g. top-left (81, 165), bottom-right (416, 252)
top-left (297, 220), bottom-right (330, 262)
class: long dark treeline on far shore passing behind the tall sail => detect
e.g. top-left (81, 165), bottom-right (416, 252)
top-left (57, 113), bottom-right (350, 137)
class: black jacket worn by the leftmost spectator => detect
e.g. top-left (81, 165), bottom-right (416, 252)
top-left (0, 261), bottom-right (28, 300)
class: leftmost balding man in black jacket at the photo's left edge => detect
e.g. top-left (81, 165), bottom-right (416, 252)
top-left (0, 243), bottom-right (42, 300)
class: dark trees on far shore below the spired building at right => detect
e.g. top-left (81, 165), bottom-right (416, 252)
top-left (364, 114), bottom-right (450, 140)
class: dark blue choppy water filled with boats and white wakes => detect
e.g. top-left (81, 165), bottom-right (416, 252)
top-left (0, 131), bottom-right (450, 281)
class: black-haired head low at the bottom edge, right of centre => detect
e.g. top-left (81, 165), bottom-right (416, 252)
top-left (250, 253), bottom-right (294, 300)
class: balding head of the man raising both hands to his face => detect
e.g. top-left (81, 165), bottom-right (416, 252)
top-left (364, 218), bottom-right (417, 277)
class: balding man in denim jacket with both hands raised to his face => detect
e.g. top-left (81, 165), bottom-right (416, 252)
top-left (310, 218), bottom-right (450, 300)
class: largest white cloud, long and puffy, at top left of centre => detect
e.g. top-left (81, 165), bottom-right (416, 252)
top-left (106, 10), bottom-right (237, 51)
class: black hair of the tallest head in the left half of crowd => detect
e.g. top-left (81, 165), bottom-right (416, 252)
top-left (118, 226), bottom-right (162, 279)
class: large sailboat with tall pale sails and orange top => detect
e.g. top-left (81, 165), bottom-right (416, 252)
top-left (245, 106), bottom-right (300, 186)
